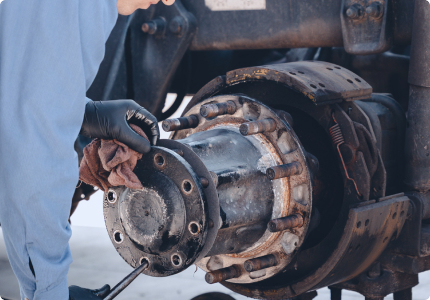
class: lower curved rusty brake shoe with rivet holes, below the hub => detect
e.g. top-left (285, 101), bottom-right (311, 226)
top-left (223, 195), bottom-right (409, 299)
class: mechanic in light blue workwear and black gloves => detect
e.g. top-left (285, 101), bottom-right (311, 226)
top-left (0, 0), bottom-right (175, 300)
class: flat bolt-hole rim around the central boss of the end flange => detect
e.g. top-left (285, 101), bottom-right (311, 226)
top-left (103, 147), bottom-right (208, 277)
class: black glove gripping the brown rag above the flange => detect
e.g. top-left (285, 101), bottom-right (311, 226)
top-left (80, 100), bottom-right (160, 153)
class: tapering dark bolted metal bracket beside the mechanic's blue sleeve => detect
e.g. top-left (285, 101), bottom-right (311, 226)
top-left (130, 1), bottom-right (197, 116)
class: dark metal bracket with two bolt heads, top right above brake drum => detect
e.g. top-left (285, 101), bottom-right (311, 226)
top-left (340, 0), bottom-right (393, 54)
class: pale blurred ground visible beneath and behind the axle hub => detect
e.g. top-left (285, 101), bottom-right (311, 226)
top-left (0, 96), bottom-right (430, 300)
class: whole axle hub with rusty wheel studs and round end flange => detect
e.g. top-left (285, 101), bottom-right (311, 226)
top-left (104, 95), bottom-right (315, 283)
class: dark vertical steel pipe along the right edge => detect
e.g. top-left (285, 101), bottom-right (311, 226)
top-left (405, 0), bottom-right (430, 191)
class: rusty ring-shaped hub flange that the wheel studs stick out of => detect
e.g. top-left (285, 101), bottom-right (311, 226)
top-left (172, 95), bottom-right (312, 283)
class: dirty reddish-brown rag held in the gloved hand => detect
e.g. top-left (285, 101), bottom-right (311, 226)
top-left (79, 124), bottom-right (148, 192)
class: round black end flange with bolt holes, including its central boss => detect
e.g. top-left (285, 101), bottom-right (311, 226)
top-left (103, 147), bottom-right (209, 277)
